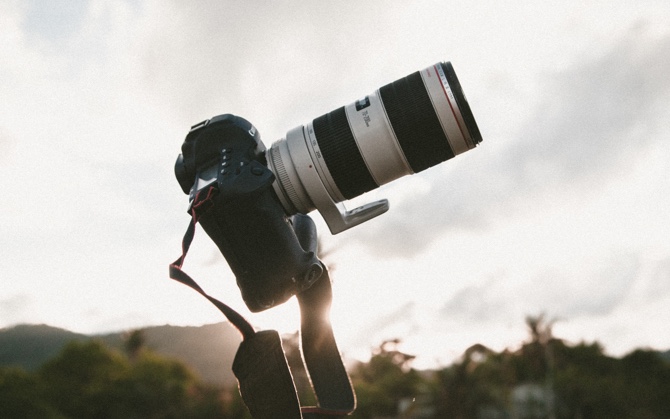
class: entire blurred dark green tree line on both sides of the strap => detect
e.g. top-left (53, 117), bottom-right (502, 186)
top-left (0, 316), bottom-right (670, 419)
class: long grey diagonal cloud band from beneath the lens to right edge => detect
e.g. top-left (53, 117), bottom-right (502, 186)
top-left (355, 27), bottom-right (670, 258)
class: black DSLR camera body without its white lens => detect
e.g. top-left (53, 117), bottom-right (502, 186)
top-left (175, 114), bottom-right (323, 312)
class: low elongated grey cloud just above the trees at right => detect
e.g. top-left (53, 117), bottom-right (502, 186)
top-left (440, 254), bottom-right (642, 324)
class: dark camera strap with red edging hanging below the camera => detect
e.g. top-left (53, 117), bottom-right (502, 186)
top-left (170, 186), bottom-right (356, 419)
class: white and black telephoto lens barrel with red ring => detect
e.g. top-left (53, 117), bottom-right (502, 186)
top-left (268, 62), bottom-right (482, 235)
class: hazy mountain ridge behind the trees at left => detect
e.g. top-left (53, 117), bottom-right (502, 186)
top-left (0, 323), bottom-right (242, 385)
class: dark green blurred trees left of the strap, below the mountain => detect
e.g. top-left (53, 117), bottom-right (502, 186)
top-left (0, 341), bottom-right (242, 418)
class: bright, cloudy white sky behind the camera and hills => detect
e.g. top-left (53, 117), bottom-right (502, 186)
top-left (0, 0), bottom-right (670, 366)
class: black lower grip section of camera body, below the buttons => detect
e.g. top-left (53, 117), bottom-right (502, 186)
top-left (200, 186), bottom-right (322, 312)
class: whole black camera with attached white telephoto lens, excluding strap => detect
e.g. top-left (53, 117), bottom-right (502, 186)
top-left (175, 62), bottom-right (482, 311)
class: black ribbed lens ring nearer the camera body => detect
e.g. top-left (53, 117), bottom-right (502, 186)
top-left (313, 106), bottom-right (377, 199)
